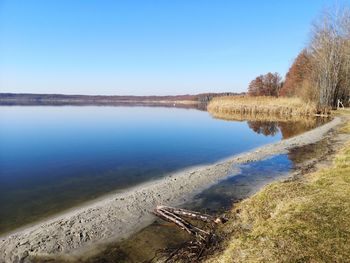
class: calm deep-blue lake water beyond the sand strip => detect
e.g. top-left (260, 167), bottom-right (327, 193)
top-left (0, 106), bottom-right (318, 233)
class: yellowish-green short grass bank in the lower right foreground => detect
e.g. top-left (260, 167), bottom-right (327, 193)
top-left (208, 111), bottom-right (350, 263)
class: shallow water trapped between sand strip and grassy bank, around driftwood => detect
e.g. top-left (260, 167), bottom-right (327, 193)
top-left (56, 154), bottom-right (294, 263)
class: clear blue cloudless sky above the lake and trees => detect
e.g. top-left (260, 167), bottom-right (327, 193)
top-left (0, 0), bottom-right (339, 95)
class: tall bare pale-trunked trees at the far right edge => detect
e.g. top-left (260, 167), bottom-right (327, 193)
top-left (310, 9), bottom-right (350, 107)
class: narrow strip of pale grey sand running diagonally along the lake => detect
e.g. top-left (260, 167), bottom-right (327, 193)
top-left (0, 118), bottom-right (342, 262)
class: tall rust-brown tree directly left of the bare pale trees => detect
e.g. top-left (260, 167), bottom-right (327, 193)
top-left (280, 49), bottom-right (315, 100)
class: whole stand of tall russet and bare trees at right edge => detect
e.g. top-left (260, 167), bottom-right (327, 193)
top-left (280, 8), bottom-right (350, 108)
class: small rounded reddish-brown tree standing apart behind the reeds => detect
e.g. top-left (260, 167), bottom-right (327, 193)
top-left (248, 72), bottom-right (282, 97)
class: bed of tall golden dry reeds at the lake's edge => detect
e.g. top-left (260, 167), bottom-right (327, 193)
top-left (207, 96), bottom-right (318, 119)
